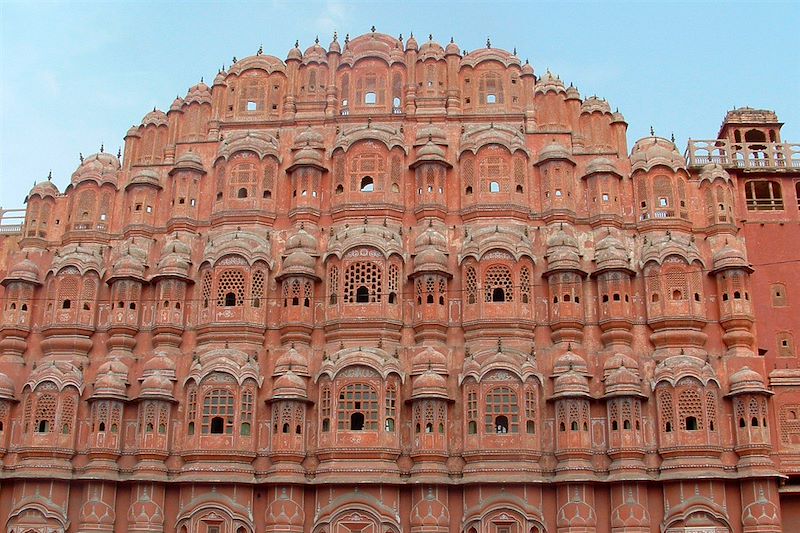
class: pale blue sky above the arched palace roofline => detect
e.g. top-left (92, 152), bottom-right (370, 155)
top-left (0, 0), bottom-right (800, 208)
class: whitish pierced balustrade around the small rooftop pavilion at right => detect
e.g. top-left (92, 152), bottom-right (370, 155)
top-left (685, 139), bottom-right (800, 171)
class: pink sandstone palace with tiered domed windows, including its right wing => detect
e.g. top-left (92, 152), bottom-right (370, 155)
top-left (0, 31), bottom-right (800, 533)
